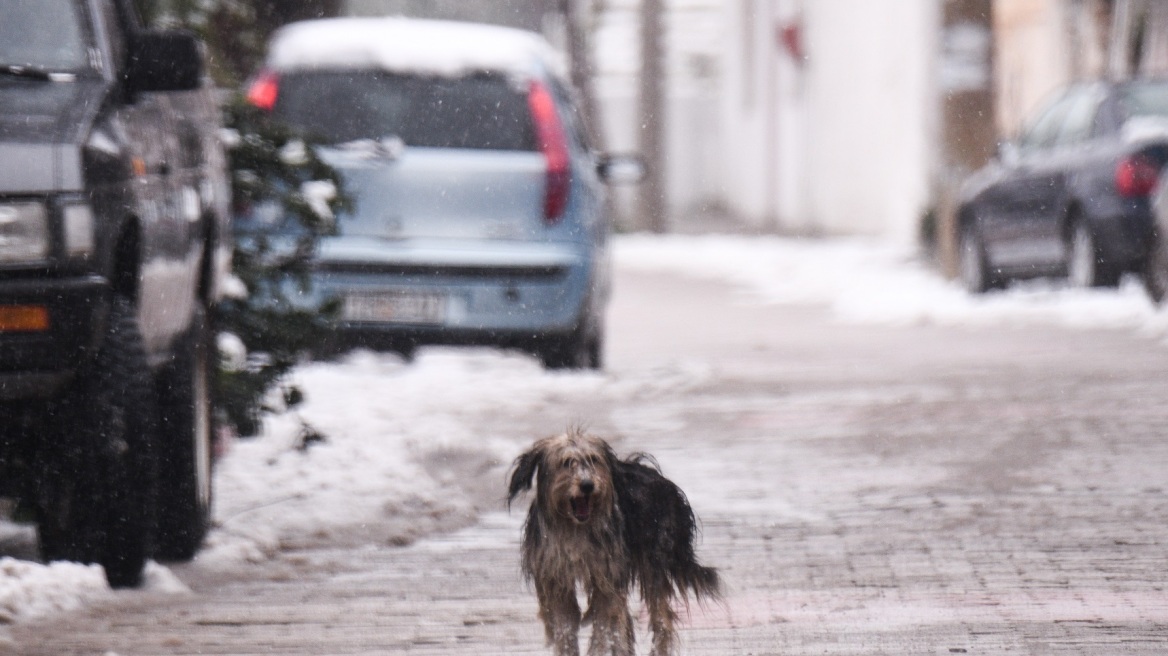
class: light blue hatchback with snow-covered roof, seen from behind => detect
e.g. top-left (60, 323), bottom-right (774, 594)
top-left (235, 18), bottom-right (639, 369)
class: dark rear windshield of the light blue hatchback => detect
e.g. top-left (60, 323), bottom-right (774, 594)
top-left (274, 70), bottom-right (536, 151)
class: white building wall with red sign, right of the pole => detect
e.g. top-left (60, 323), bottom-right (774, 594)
top-left (722, 0), bottom-right (939, 239)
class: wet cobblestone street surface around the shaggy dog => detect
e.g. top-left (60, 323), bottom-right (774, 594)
top-left (0, 272), bottom-right (1168, 656)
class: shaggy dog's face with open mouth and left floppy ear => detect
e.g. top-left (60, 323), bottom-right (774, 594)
top-left (510, 432), bottom-right (616, 524)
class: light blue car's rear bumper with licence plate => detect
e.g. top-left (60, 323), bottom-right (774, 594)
top-left (301, 236), bottom-right (598, 344)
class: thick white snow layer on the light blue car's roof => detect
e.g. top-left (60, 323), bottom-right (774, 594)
top-left (265, 18), bottom-right (565, 77)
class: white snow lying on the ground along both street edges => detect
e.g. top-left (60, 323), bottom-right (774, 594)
top-left (0, 235), bottom-right (1168, 625)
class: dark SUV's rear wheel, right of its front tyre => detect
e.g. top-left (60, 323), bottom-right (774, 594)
top-left (155, 308), bottom-right (214, 561)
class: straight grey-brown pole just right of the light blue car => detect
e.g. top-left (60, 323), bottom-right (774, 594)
top-left (639, 0), bottom-right (667, 232)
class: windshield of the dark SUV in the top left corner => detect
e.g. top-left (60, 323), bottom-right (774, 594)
top-left (0, 0), bottom-right (89, 71)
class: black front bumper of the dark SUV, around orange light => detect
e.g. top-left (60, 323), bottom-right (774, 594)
top-left (0, 277), bottom-right (109, 400)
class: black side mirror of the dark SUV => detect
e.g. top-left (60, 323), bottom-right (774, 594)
top-left (126, 30), bottom-right (203, 93)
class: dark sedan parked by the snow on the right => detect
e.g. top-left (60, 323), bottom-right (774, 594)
top-left (957, 79), bottom-right (1168, 292)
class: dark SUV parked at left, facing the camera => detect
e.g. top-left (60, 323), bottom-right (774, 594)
top-left (0, 0), bottom-right (230, 587)
